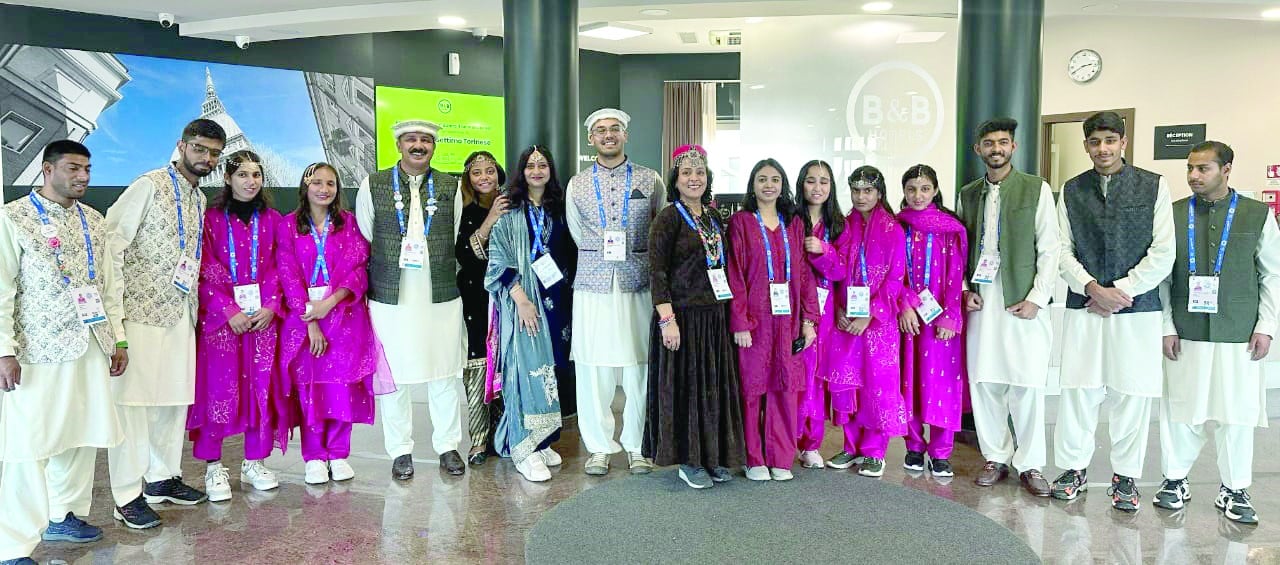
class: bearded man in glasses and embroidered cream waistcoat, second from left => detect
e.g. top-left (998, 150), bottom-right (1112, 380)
top-left (106, 119), bottom-right (227, 529)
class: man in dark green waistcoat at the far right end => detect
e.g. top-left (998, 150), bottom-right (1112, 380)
top-left (1153, 141), bottom-right (1280, 524)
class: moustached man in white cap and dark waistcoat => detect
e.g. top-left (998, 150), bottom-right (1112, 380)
top-left (356, 120), bottom-right (466, 480)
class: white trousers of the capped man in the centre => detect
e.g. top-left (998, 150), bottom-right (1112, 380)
top-left (576, 363), bottom-right (649, 454)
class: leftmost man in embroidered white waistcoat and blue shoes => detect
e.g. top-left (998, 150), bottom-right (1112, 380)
top-left (0, 140), bottom-right (129, 564)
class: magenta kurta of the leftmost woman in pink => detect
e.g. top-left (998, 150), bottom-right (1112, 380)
top-left (187, 208), bottom-right (293, 451)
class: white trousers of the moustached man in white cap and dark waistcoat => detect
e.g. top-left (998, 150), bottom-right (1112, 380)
top-left (378, 377), bottom-right (463, 459)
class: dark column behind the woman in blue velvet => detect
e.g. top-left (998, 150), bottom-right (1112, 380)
top-left (502, 0), bottom-right (584, 176)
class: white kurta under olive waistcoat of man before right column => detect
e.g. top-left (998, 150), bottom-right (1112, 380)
top-left (965, 182), bottom-right (1059, 388)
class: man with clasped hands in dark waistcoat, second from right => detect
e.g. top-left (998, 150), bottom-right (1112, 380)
top-left (1053, 111), bottom-right (1174, 512)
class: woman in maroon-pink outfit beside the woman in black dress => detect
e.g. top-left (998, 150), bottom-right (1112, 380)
top-left (727, 159), bottom-right (818, 480)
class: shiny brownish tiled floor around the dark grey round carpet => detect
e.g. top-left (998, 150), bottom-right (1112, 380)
top-left (20, 389), bottom-right (1280, 565)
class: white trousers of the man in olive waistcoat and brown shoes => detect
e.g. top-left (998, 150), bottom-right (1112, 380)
top-left (969, 383), bottom-right (1047, 473)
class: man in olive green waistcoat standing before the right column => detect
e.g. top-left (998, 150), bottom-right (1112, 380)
top-left (956, 118), bottom-right (1059, 496)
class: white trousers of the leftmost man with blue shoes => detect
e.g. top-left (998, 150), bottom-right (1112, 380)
top-left (0, 447), bottom-right (97, 560)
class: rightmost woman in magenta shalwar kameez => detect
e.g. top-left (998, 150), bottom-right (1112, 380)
top-left (897, 165), bottom-right (969, 477)
